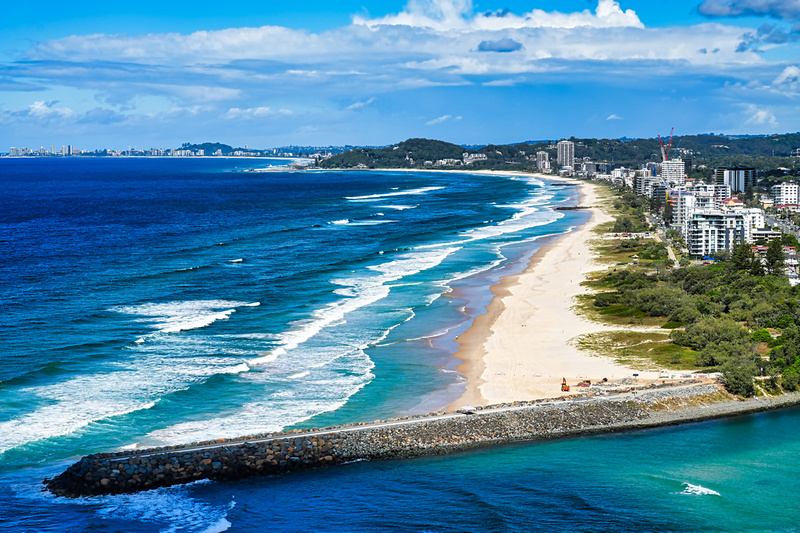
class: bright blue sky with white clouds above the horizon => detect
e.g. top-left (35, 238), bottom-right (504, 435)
top-left (0, 0), bottom-right (800, 151)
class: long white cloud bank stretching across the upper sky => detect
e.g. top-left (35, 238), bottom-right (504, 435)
top-left (21, 4), bottom-right (764, 75)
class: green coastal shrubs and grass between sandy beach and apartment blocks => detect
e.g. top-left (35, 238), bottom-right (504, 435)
top-left (580, 186), bottom-right (800, 396)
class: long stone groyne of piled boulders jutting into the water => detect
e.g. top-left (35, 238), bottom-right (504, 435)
top-left (45, 385), bottom-right (800, 497)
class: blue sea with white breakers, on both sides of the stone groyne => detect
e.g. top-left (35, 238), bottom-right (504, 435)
top-left (0, 159), bottom-right (800, 533)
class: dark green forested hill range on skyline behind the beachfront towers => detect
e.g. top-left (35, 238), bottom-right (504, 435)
top-left (322, 133), bottom-right (800, 169)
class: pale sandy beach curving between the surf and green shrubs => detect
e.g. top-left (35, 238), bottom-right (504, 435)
top-left (450, 176), bottom-right (658, 409)
